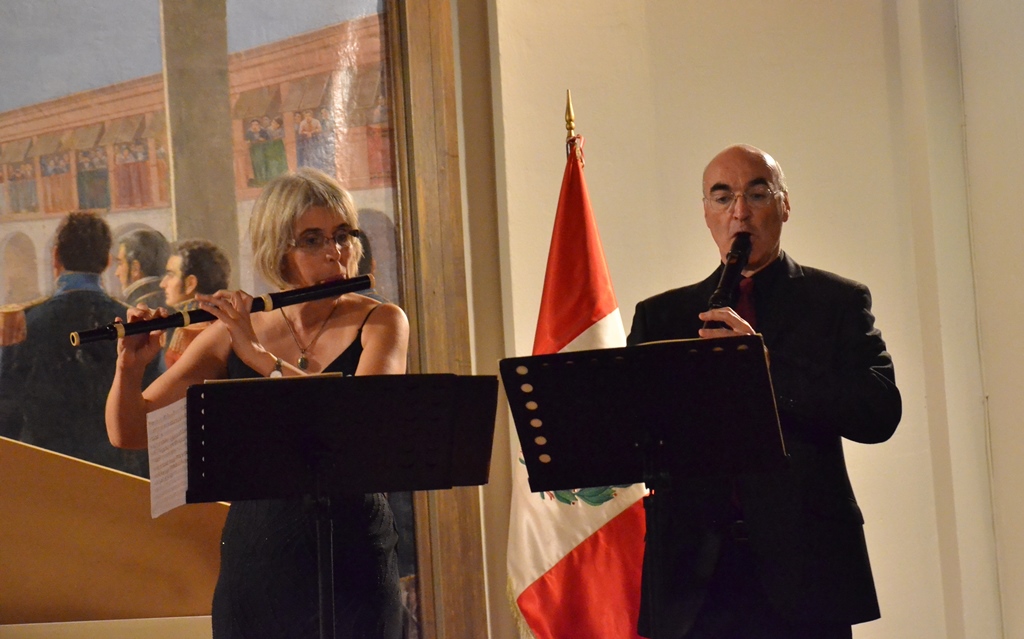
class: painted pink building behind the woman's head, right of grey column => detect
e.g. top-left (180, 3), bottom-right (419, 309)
top-left (230, 14), bottom-right (401, 302)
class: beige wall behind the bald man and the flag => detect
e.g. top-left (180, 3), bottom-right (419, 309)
top-left (475, 0), bottom-right (1024, 639)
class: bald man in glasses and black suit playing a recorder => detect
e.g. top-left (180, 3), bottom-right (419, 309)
top-left (628, 145), bottom-right (902, 639)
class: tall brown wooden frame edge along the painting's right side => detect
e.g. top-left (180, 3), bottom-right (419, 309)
top-left (386, 0), bottom-right (488, 639)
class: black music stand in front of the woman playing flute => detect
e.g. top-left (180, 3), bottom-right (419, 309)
top-left (185, 375), bottom-right (498, 638)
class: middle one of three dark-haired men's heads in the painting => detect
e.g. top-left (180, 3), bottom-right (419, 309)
top-left (115, 228), bottom-right (171, 308)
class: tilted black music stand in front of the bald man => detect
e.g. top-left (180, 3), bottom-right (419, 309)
top-left (500, 335), bottom-right (786, 636)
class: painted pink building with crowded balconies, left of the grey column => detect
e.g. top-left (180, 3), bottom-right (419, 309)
top-left (0, 108), bottom-right (172, 308)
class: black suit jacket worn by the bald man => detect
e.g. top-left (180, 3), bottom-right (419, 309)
top-left (628, 254), bottom-right (902, 639)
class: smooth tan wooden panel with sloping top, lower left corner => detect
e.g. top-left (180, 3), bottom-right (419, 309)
top-left (0, 437), bottom-right (227, 625)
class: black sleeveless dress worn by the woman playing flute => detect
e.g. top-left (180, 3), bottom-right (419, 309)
top-left (213, 311), bottom-right (401, 639)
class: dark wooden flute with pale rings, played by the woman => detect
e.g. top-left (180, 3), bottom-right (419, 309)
top-left (71, 275), bottom-right (374, 346)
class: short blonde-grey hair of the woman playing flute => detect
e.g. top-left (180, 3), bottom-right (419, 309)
top-left (249, 167), bottom-right (362, 289)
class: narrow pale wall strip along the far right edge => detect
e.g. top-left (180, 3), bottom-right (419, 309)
top-left (958, 0), bottom-right (1024, 639)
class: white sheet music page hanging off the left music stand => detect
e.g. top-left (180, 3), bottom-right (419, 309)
top-left (145, 397), bottom-right (188, 519)
